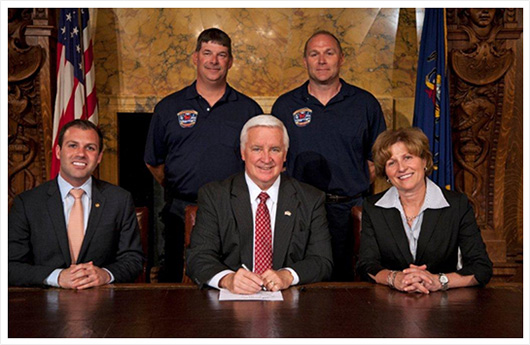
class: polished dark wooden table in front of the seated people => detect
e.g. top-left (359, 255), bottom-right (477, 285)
top-left (8, 283), bottom-right (523, 338)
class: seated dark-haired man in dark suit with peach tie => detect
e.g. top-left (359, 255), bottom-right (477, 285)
top-left (8, 120), bottom-right (143, 289)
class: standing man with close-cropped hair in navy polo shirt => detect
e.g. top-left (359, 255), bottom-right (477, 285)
top-left (272, 31), bottom-right (386, 281)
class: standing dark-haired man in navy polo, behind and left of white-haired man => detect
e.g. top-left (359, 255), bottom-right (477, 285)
top-left (144, 28), bottom-right (263, 281)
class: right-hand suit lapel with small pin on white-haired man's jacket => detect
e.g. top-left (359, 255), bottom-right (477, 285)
top-left (272, 175), bottom-right (299, 269)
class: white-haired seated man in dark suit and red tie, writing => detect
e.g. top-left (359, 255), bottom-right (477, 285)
top-left (187, 115), bottom-right (333, 294)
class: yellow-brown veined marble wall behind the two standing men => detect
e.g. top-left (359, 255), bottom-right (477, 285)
top-left (92, 8), bottom-right (422, 183)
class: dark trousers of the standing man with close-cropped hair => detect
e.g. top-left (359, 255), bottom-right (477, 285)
top-left (326, 197), bottom-right (362, 281)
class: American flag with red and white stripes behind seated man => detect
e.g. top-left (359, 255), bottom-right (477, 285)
top-left (50, 8), bottom-right (98, 179)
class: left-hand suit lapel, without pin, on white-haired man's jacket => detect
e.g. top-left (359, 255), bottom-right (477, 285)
top-left (230, 173), bottom-right (254, 270)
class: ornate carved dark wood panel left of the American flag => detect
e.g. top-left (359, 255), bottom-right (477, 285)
top-left (8, 8), bottom-right (55, 206)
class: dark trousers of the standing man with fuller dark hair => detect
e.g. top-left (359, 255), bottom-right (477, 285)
top-left (158, 199), bottom-right (193, 283)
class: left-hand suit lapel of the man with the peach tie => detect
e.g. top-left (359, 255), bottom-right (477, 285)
top-left (46, 179), bottom-right (72, 266)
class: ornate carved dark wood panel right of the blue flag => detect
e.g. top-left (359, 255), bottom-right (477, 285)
top-left (447, 9), bottom-right (522, 272)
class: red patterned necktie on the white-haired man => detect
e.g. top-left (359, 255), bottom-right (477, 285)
top-left (254, 192), bottom-right (272, 274)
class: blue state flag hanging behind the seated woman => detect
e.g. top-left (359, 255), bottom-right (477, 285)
top-left (413, 8), bottom-right (454, 189)
